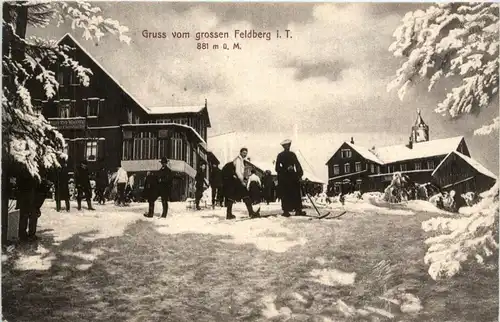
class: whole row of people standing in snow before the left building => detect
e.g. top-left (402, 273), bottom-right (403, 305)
top-left (9, 140), bottom-right (304, 240)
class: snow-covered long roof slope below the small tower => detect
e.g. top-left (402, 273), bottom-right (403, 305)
top-left (373, 136), bottom-right (464, 163)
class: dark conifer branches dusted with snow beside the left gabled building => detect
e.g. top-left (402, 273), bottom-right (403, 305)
top-left (2, 0), bottom-right (130, 179)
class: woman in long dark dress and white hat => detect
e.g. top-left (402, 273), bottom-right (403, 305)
top-left (276, 140), bottom-right (305, 217)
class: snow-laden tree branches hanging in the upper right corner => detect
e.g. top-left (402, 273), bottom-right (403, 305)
top-left (388, 2), bottom-right (500, 134)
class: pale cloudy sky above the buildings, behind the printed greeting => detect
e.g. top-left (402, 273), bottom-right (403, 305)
top-left (30, 2), bottom-right (499, 179)
